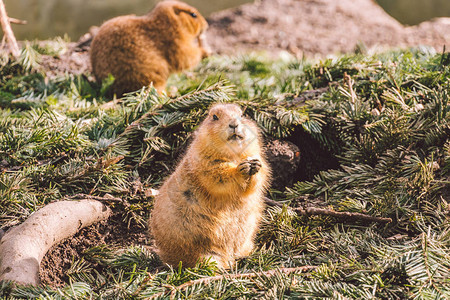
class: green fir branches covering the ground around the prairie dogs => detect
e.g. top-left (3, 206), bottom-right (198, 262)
top-left (0, 43), bottom-right (450, 299)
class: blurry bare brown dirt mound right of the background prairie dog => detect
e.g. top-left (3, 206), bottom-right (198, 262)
top-left (207, 0), bottom-right (450, 58)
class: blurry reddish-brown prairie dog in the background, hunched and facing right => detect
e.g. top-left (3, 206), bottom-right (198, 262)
top-left (91, 1), bottom-right (210, 96)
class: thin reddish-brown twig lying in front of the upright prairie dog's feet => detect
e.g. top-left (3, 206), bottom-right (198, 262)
top-left (149, 266), bottom-right (317, 299)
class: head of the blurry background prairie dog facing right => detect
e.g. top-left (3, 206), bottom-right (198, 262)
top-left (153, 0), bottom-right (208, 37)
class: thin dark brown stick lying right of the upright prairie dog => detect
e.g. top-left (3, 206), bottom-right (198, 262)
top-left (264, 197), bottom-right (392, 223)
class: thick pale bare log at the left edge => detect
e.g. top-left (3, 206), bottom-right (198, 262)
top-left (0, 200), bottom-right (111, 285)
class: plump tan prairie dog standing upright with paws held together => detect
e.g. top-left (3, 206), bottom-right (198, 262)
top-left (149, 104), bottom-right (270, 268)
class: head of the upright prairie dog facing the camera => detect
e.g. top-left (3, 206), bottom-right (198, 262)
top-left (198, 104), bottom-right (259, 156)
